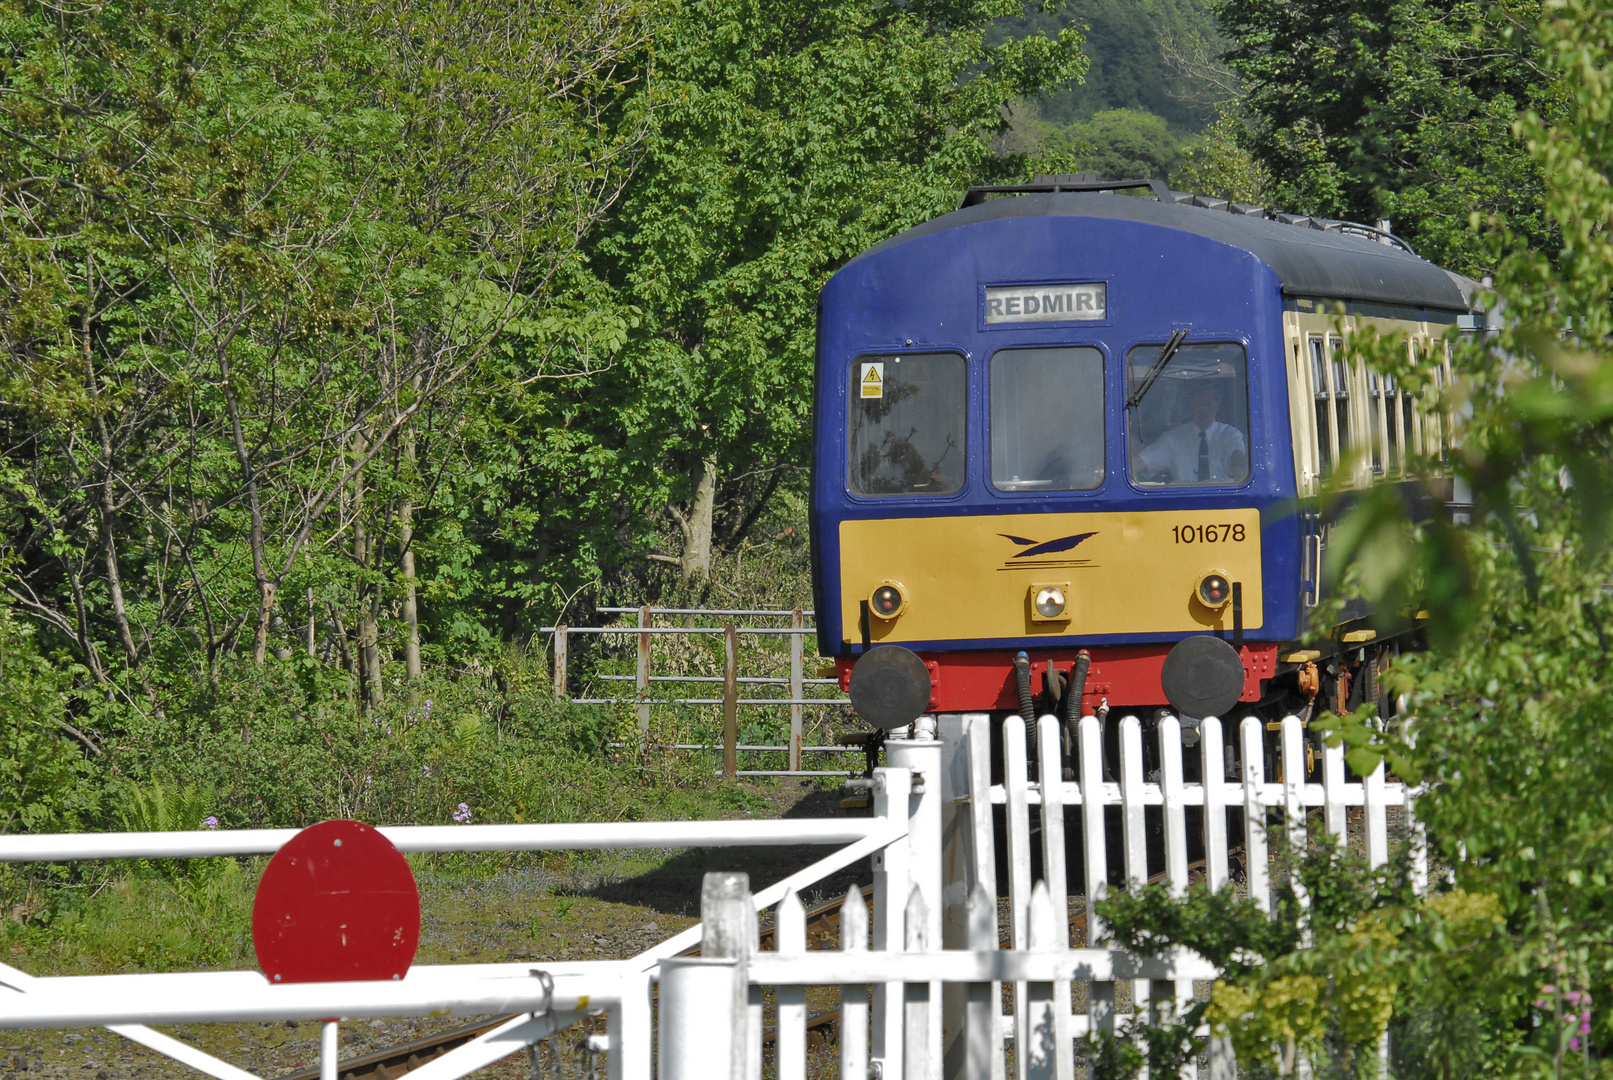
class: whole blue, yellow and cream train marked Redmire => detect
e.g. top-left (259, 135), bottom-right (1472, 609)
top-left (811, 177), bottom-right (1476, 754)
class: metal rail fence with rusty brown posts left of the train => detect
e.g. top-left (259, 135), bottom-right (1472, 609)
top-left (539, 604), bottom-right (852, 779)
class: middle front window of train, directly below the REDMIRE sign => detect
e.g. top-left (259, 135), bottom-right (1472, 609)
top-left (992, 347), bottom-right (1103, 492)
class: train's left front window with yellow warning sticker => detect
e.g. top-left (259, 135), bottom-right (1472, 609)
top-left (847, 353), bottom-right (968, 495)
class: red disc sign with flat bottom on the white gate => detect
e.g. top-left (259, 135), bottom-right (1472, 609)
top-left (252, 820), bottom-right (419, 983)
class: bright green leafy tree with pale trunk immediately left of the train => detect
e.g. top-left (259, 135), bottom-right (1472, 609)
top-left (442, 0), bottom-right (1082, 629)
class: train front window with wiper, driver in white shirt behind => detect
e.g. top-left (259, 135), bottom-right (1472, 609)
top-left (1126, 342), bottom-right (1248, 487)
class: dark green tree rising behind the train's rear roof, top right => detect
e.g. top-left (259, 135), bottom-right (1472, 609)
top-left (1211, 0), bottom-right (1557, 276)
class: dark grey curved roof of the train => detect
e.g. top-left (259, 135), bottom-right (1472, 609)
top-left (865, 177), bottom-right (1478, 313)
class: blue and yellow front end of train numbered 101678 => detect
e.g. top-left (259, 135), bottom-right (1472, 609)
top-left (811, 195), bottom-right (1302, 728)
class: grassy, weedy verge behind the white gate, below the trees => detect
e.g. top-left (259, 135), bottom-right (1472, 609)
top-left (0, 509), bottom-right (860, 975)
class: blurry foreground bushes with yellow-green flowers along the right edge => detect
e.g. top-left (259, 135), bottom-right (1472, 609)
top-left (1107, 0), bottom-right (1613, 1080)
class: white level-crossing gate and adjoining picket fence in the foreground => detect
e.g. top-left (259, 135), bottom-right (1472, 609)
top-left (0, 714), bottom-right (1428, 1080)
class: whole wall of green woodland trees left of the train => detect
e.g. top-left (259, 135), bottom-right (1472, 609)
top-left (0, 0), bottom-right (1082, 754)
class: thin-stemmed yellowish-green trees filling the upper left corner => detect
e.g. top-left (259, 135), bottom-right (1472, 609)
top-left (0, 0), bottom-right (647, 706)
